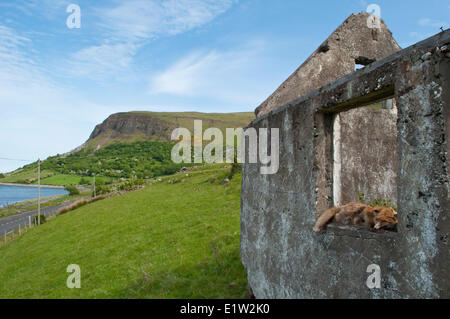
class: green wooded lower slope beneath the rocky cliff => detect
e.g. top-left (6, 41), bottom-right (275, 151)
top-left (0, 141), bottom-right (188, 185)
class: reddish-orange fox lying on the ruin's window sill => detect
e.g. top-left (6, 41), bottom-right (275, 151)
top-left (314, 202), bottom-right (398, 232)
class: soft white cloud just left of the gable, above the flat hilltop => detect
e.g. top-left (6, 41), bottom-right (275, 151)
top-left (149, 41), bottom-right (267, 105)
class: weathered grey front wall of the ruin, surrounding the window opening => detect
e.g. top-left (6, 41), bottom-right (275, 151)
top-left (241, 31), bottom-right (450, 298)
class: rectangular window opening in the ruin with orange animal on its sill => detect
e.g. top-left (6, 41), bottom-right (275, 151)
top-left (315, 99), bottom-right (398, 231)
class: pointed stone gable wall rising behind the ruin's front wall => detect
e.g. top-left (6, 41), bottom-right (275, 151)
top-left (255, 12), bottom-right (400, 117)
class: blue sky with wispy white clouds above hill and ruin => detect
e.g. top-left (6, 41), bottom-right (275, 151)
top-left (0, 0), bottom-right (450, 172)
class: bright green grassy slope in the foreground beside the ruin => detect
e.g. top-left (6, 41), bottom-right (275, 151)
top-left (0, 166), bottom-right (247, 298)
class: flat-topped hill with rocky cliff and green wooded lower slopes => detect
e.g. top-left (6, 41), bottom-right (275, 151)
top-left (0, 112), bottom-right (254, 185)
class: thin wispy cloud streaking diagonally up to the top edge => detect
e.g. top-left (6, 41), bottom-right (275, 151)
top-left (69, 0), bottom-right (234, 79)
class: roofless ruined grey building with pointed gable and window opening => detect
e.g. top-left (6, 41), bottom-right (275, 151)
top-left (241, 13), bottom-right (450, 298)
